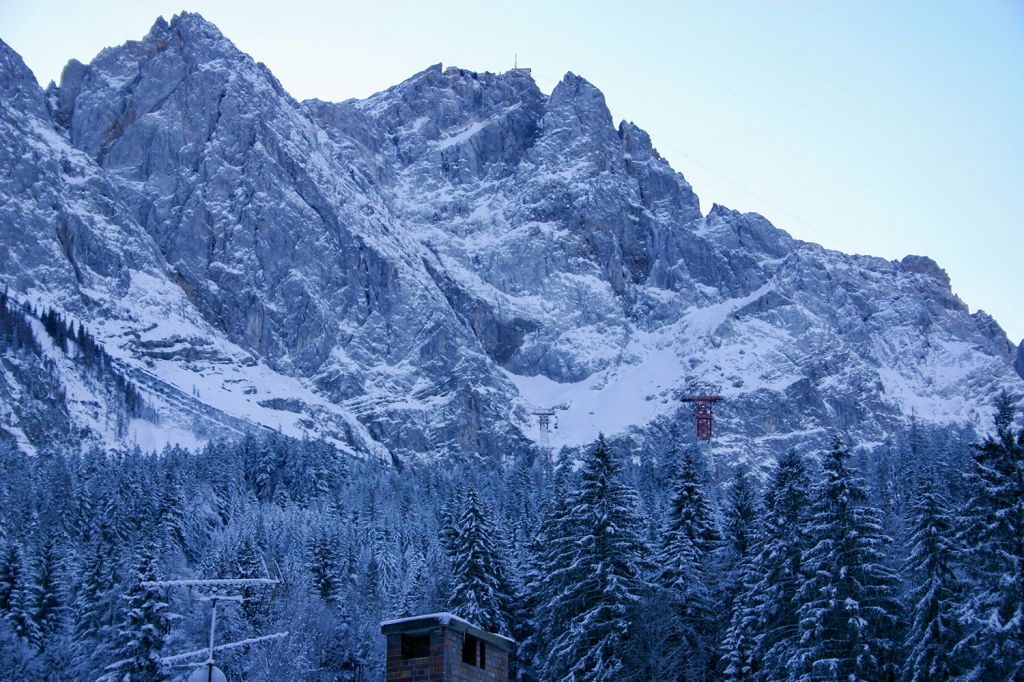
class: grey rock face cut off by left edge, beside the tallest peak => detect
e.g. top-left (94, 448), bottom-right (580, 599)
top-left (0, 42), bottom-right (161, 307)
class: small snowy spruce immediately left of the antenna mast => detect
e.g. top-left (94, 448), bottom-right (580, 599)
top-left (106, 549), bottom-right (175, 682)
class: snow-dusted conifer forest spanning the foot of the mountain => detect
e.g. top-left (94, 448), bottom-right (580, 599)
top-left (0, 396), bottom-right (1024, 681)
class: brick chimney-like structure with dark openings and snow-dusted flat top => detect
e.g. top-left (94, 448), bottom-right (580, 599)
top-left (381, 613), bottom-right (514, 682)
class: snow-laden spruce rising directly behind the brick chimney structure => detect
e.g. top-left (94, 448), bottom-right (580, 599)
top-left (447, 488), bottom-right (513, 635)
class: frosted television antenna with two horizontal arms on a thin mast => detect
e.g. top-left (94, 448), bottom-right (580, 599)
top-left (142, 578), bottom-right (288, 682)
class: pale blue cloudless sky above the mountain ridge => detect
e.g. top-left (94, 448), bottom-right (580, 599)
top-left (6, 0), bottom-right (1024, 343)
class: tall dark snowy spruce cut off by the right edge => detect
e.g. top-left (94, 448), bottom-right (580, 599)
top-left (956, 393), bottom-right (1024, 680)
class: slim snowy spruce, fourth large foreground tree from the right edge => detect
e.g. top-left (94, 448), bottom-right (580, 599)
top-left (746, 451), bottom-right (811, 680)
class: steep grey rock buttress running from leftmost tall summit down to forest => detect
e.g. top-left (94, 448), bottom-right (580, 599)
top-left (38, 15), bottom-right (528, 452)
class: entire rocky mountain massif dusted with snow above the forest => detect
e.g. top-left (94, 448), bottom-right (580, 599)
top-left (0, 13), bottom-right (1024, 458)
